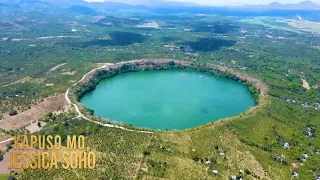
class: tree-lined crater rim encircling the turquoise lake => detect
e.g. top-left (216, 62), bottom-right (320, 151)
top-left (68, 59), bottom-right (268, 131)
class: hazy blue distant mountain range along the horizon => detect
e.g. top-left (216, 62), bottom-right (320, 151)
top-left (0, 0), bottom-right (320, 13)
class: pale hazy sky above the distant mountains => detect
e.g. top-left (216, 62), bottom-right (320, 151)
top-left (85, 0), bottom-right (320, 5)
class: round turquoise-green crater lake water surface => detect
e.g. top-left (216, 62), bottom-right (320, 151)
top-left (81, 70), bottom-right (254, 130)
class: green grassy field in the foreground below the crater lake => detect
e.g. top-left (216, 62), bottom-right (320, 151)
top-left (18, 98), bottom-right (320, 179)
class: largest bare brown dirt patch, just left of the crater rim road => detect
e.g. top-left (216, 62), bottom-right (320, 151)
top-left (1, 95), bottom-right (67, 130)
